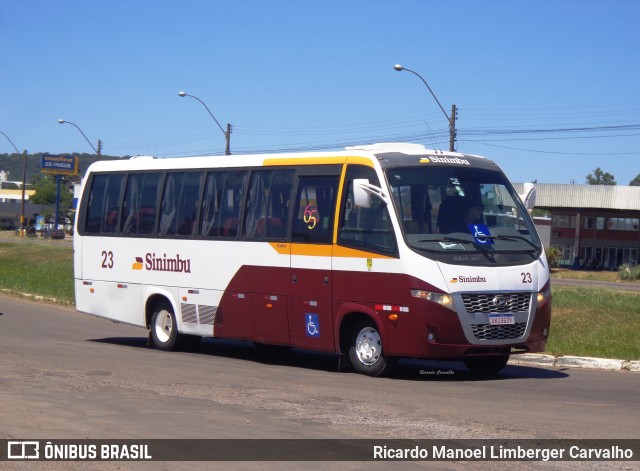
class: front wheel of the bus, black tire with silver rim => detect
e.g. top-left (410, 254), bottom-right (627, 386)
top-left (349, 320), bottom-right (390, 376)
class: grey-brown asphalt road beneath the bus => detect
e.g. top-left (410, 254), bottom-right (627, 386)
top-left (0, 295), bottom-right (640, 470)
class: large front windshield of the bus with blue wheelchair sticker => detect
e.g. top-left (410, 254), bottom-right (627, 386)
top-left (386, 166), bottom-right (542, 264)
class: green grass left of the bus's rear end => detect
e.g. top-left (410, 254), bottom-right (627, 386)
top-left (0, 240), bottom-right (74, 302)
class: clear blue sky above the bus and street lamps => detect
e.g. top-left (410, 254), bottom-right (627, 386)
top-left (0, 0), bottom-right (640, 185)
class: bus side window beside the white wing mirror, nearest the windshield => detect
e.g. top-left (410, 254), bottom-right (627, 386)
top-left (338, 165), bottom-right (398, 256)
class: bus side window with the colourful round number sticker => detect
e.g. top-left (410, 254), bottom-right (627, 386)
top-left (291, 176), bottom-right (339, 244)
